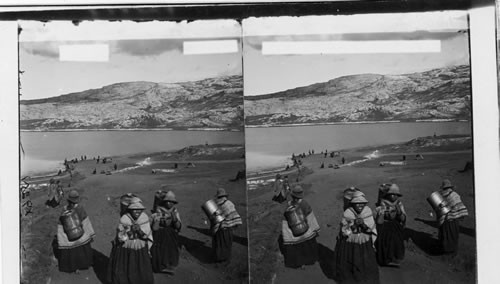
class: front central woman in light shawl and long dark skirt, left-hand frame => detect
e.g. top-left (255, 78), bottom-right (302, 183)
top-left (108, 197), bottom-right (154, 284)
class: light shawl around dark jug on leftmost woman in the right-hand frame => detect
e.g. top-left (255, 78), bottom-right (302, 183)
top-left (281, 199), bottom-right (320, 245)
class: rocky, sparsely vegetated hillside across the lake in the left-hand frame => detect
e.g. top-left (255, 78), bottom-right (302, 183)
top-left (20, 76), bottom-right (243, 130)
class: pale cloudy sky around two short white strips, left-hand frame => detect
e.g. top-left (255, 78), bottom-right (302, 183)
top-left (19, 21), bottom-right (242, 100)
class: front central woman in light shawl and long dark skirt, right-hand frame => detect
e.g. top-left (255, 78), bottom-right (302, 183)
top-left (335, 192), bottom-right (379, 283)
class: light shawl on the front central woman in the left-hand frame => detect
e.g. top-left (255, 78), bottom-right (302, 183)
top-left (117, 212), bottom-right (153, 249)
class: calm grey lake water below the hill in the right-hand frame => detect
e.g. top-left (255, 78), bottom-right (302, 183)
top-left (245, 122), bottom-right (472, 172)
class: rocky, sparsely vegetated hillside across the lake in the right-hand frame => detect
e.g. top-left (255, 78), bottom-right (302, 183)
top-left (245, 65), bottom-right (471, 125)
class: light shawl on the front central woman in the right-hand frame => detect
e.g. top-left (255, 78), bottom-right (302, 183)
top-left (340, 206), bottom-right (377, 244)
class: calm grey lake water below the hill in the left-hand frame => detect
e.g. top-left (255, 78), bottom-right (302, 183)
top-left (21, 130), bottom-right (245, 176)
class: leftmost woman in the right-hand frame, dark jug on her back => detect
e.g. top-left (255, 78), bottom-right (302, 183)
top-left (280, 185), bottom-right (320, 268)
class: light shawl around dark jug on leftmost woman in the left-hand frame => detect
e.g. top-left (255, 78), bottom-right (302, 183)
top-left (57, 204), bottom-right (95, 249)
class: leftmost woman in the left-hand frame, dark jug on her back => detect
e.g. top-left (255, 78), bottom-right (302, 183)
top-left (56, 190), bottom-right (95, 273)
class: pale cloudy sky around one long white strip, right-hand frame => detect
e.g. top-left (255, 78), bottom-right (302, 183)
top-left (243, 12), bottom-right (469, 96)
